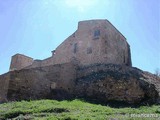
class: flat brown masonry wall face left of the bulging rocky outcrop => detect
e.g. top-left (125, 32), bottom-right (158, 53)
top-left (5, 63), bottom-right (76, 100)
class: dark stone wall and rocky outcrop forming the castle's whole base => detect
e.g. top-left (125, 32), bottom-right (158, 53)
top-left (0, 63), bottom-right (160, 104)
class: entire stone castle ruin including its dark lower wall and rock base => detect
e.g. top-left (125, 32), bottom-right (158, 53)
top-left (0, 20), bottom-right (160, 104)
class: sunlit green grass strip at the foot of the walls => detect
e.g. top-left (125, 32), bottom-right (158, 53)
top-left (0, 100), bottom-right (160, 120)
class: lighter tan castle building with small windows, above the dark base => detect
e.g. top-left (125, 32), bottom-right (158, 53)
top-left (10, 20), bottom-right (131, 71)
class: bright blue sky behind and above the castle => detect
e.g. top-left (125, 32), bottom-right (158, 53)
top-left (0, 0), bottom-right (160, 74)
